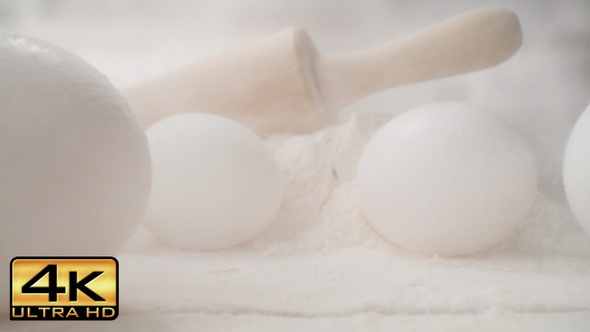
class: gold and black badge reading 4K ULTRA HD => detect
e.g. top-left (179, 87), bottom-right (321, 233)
top-left (10, 257), bottom-right (119, 320)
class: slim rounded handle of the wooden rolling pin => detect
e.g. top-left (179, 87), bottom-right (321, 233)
top-left (316, 8), bottom-right (522, 110)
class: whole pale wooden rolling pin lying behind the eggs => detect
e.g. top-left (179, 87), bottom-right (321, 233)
top-left (124, 8), bottom-right (522, 137)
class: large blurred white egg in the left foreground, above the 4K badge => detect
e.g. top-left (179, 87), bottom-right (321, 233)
top-left (0, 34), bottom-right (151, 310)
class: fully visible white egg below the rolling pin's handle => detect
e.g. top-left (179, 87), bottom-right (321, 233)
top-left (356, 103), bottom-right (537, 255)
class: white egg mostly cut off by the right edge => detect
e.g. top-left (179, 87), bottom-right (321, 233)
top-left (563, 107), bottom-right (590, 234)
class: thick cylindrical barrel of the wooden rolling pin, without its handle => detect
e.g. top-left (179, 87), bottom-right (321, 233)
top-left (124, 29), bottom-right (326, 136)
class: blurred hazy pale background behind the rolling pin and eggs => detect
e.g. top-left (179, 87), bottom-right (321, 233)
top-left (0, 0), bottom-right (590, 200)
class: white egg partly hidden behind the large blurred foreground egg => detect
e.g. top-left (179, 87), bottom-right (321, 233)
top-left (144, 113), bottom-right (283, 250)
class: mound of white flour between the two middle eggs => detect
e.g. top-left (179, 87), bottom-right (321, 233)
top-left (253, 115), bottom-right (380, 255)
